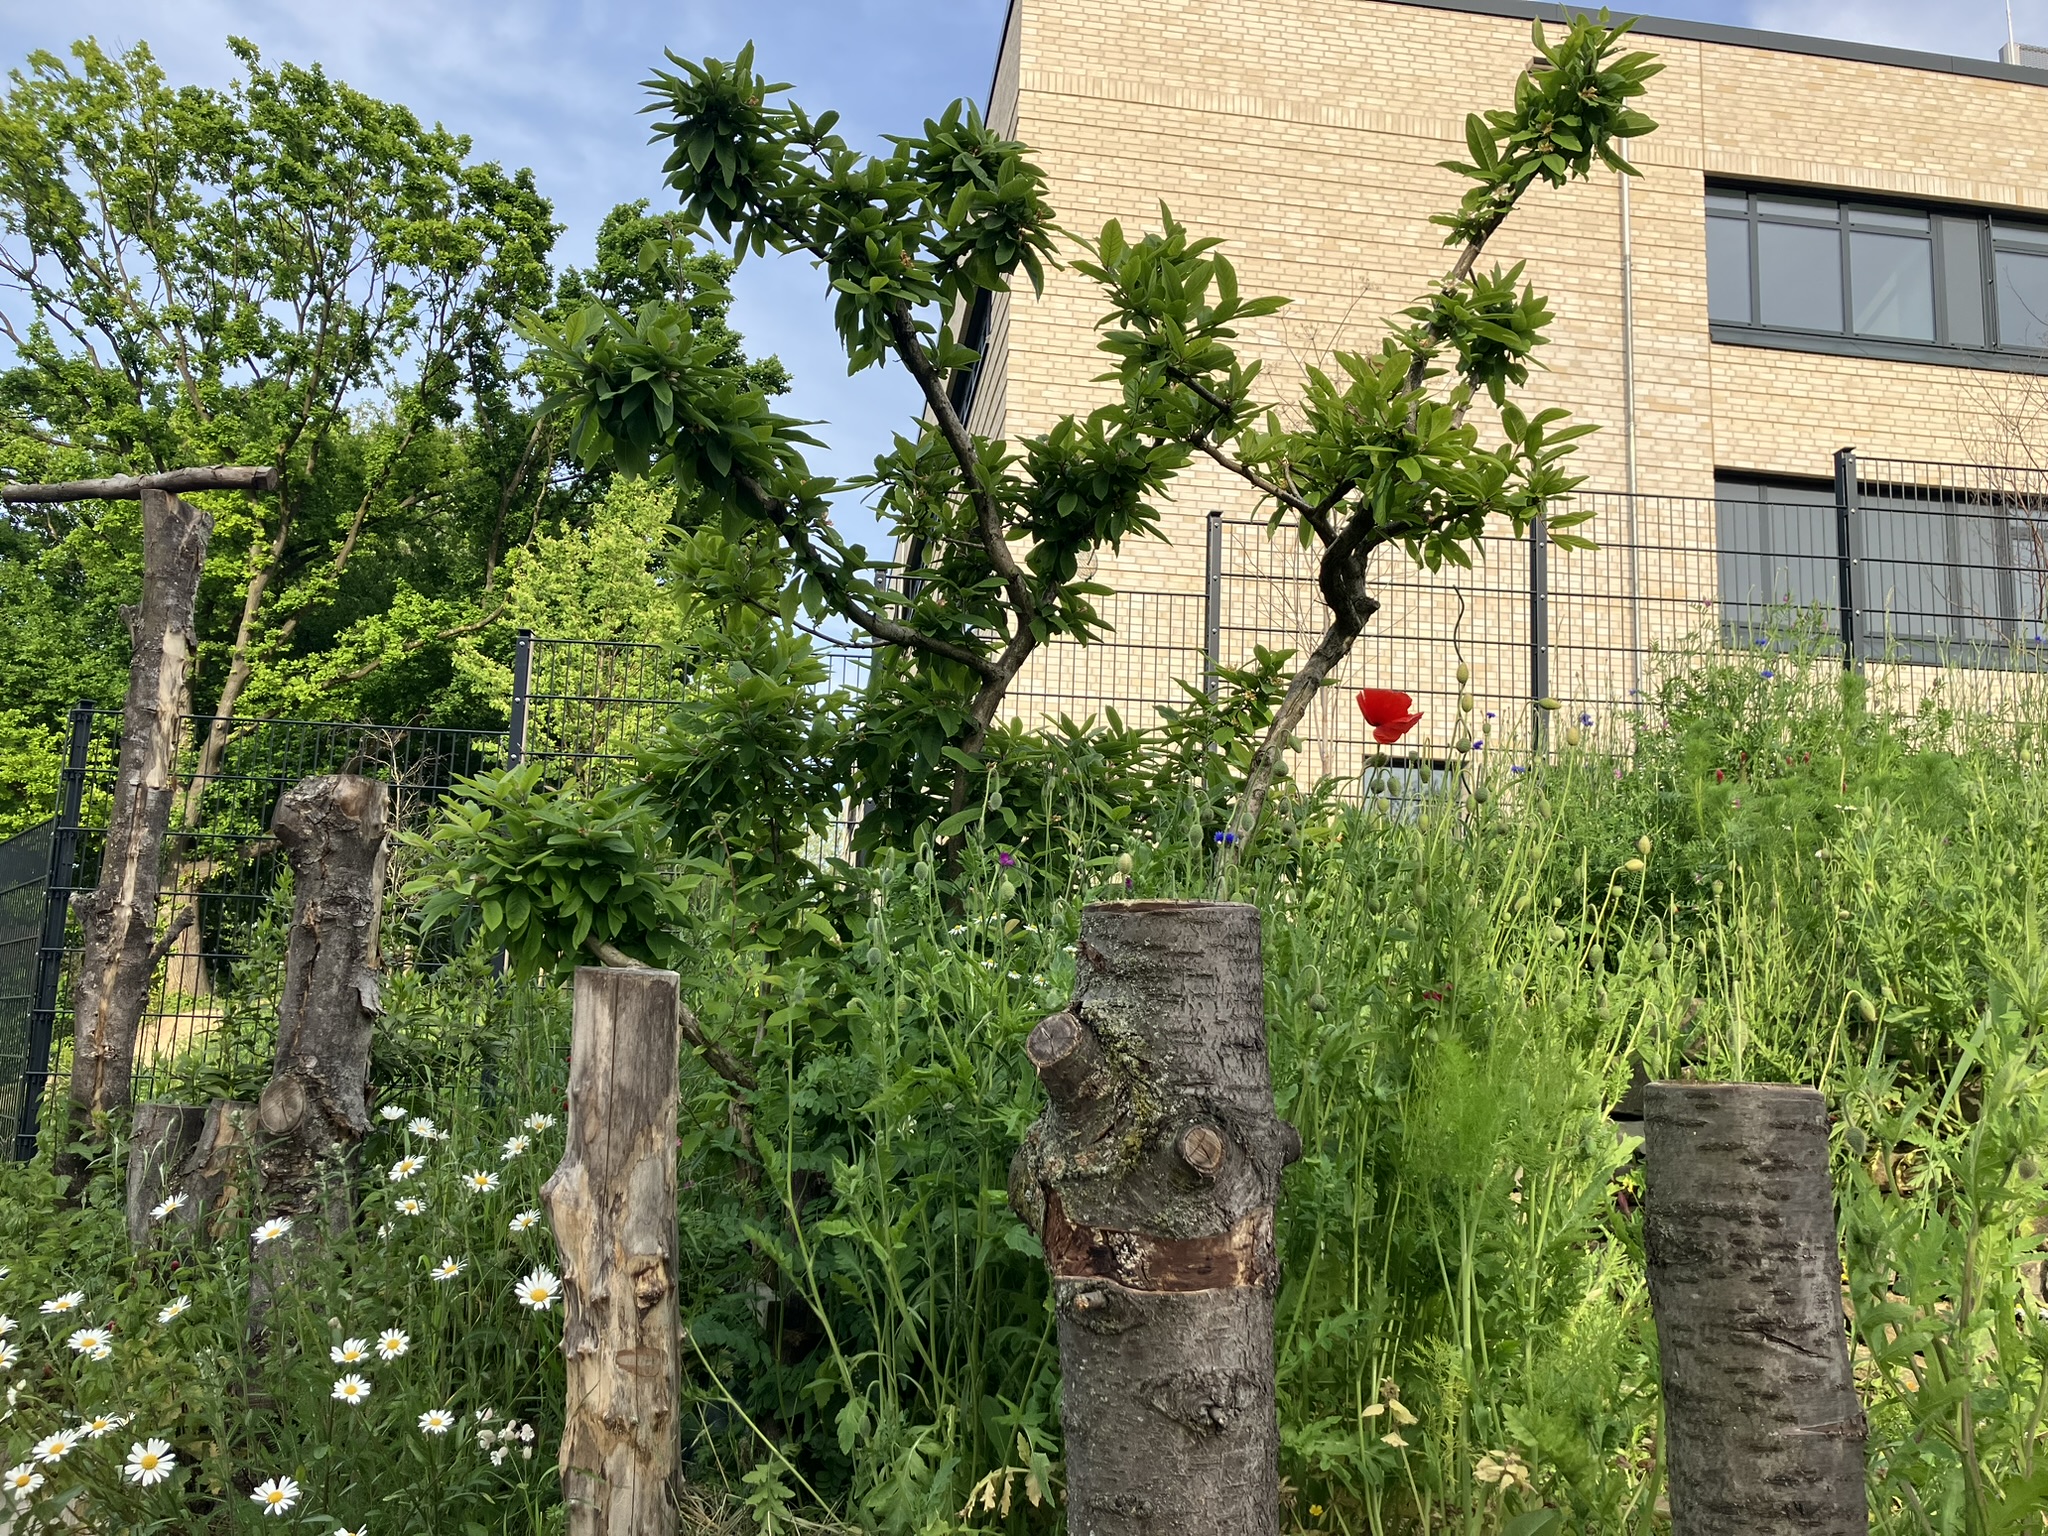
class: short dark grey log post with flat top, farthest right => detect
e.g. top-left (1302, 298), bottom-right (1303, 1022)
top-left (1642, 1083), bottom-right (1870, 1536)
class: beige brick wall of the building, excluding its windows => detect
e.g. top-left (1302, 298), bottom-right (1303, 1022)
top-left (975, 0), bottom-right (2048, 766)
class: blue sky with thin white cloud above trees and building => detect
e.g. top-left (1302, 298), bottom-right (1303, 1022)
top-left (0, 0), bottom-right (2048, 547)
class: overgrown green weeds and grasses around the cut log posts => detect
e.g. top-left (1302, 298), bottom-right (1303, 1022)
top-left (0, 649), bottom-right (2048, 1536)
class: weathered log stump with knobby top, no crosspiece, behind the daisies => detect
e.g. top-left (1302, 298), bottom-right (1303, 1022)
top-left (256, 774), bottom-right (387, 1239)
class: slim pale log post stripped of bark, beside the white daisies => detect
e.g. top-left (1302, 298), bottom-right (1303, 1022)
top-left (541, 967), bottom-right (682, 1536)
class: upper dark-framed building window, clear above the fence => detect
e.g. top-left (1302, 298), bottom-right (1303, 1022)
top-left (1706, 186), bottom-right (2048, 371)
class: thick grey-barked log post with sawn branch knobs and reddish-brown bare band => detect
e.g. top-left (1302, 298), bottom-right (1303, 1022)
top-left (1010, 901), bottom-right (1300, 1536)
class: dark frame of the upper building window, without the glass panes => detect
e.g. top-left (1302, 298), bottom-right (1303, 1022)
top-left (1704, 180), bottom-right (2048, 375)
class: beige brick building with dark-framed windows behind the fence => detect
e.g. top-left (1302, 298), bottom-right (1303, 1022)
top-left (967, 0), bottom-right (2048, 772)
